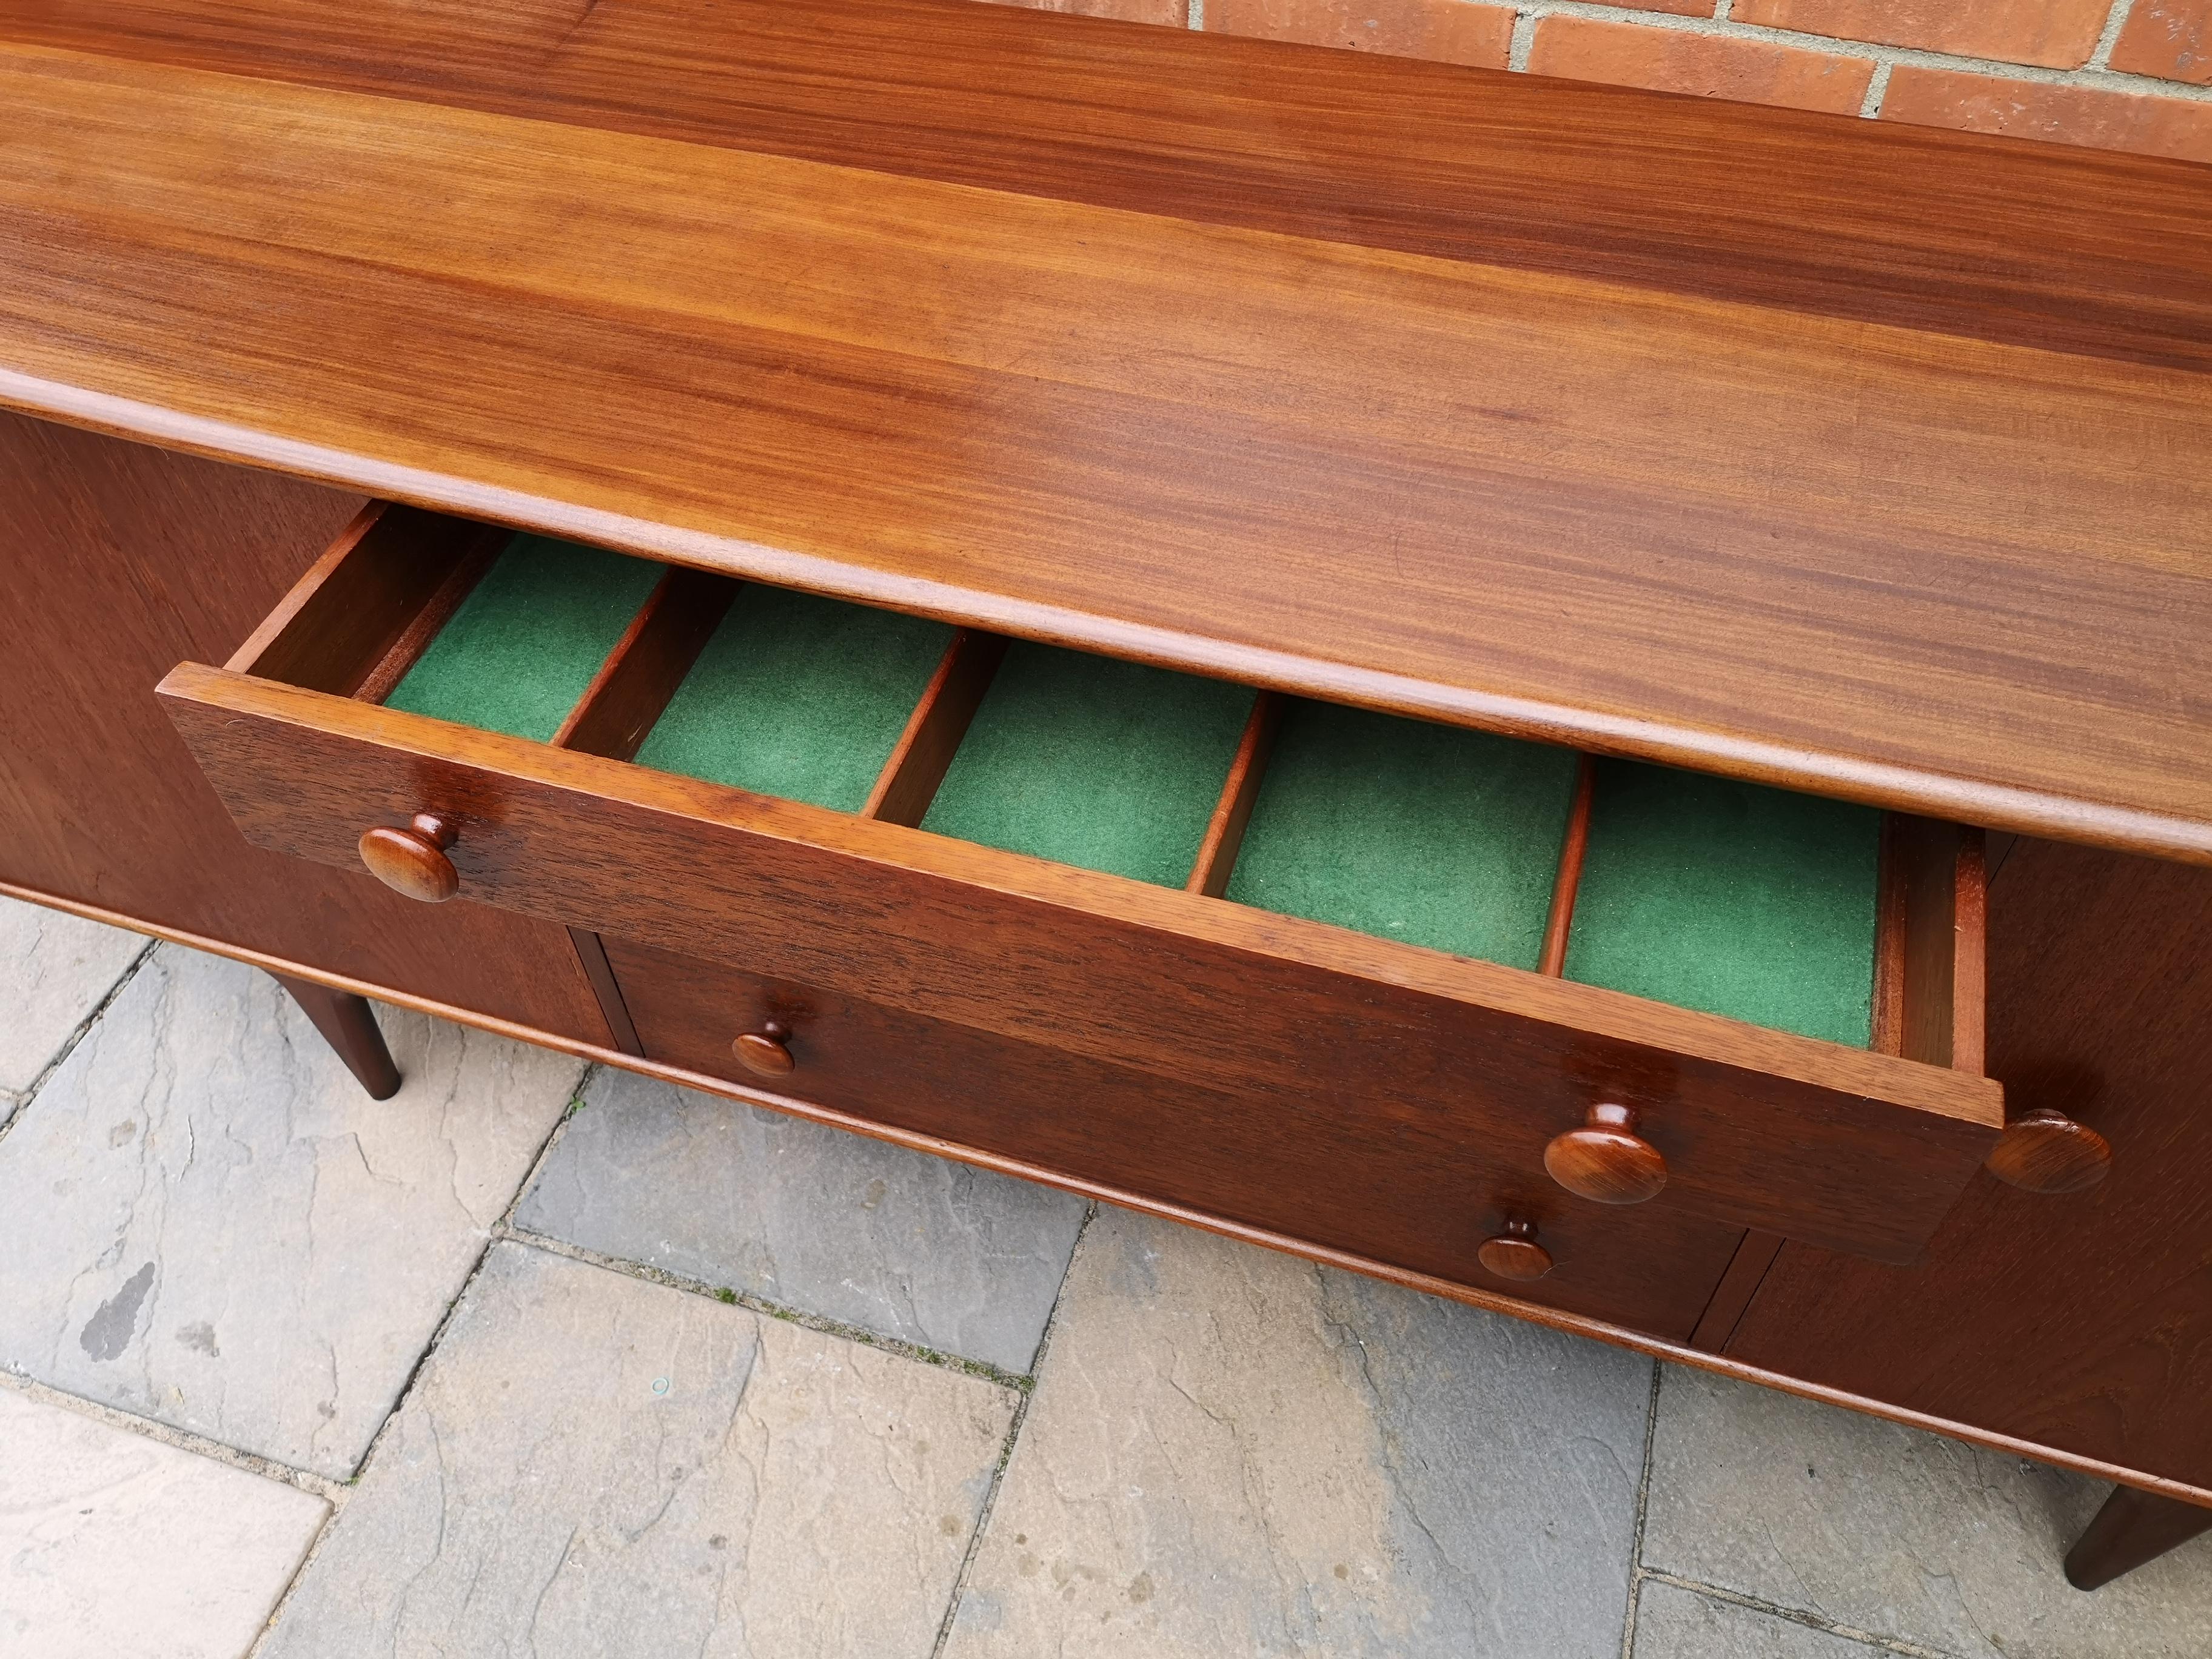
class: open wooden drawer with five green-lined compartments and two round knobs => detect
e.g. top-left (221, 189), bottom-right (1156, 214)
top-left (161, 506), bottom-right (2002, 1261)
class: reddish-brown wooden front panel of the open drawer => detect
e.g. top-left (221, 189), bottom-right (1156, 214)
top-left (164, 666), bottom-right (2002, 1261)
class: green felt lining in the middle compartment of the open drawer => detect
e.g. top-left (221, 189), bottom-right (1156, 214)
top-left (922, 642), bottom-right (1252, 887)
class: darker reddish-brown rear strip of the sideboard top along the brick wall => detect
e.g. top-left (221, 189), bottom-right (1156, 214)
top-left (7, 0), bottom-right (2212, 365)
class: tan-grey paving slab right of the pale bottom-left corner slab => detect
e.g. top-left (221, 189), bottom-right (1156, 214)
top-left (263, 1243), bottom-right (1015, 1659)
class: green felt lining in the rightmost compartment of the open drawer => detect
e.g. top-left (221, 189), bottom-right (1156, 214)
top-left (1566, 761), bottom-right (1882, 1048)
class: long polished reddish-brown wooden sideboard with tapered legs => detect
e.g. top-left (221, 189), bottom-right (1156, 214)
top-left (0, 0), bottom-right (2212, 1584)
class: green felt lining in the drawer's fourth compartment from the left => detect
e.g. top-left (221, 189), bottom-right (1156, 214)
top-left (1228, 701), bottom-right (1575, 969)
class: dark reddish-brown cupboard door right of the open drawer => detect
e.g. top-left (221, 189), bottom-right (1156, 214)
top-left (1728, 839), bottom-right (2212, 1489)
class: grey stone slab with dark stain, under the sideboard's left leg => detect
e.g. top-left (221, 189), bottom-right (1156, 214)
top-left (0, 945), bottom-right (581, 1478)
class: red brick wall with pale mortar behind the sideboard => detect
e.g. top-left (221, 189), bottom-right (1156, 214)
top-left (991, 0), bottom-right (2212, 161)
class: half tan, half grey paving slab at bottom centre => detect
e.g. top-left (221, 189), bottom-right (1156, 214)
top-left (947, 1210), bottom-right (1652, 1659)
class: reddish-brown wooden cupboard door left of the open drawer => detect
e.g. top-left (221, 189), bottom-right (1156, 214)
top-left (0, 411), bottom-right (606, 1044)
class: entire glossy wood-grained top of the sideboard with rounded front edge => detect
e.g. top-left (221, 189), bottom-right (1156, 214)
top-left (0, 0), bottom-right (2212, 863)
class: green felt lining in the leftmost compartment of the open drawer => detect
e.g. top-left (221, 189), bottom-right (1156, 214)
top-left (385, 535), bottom-right (662, 743)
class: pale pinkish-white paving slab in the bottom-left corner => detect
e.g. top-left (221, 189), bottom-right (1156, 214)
top-left (0, 1387), bottom-right (327, 1659)
